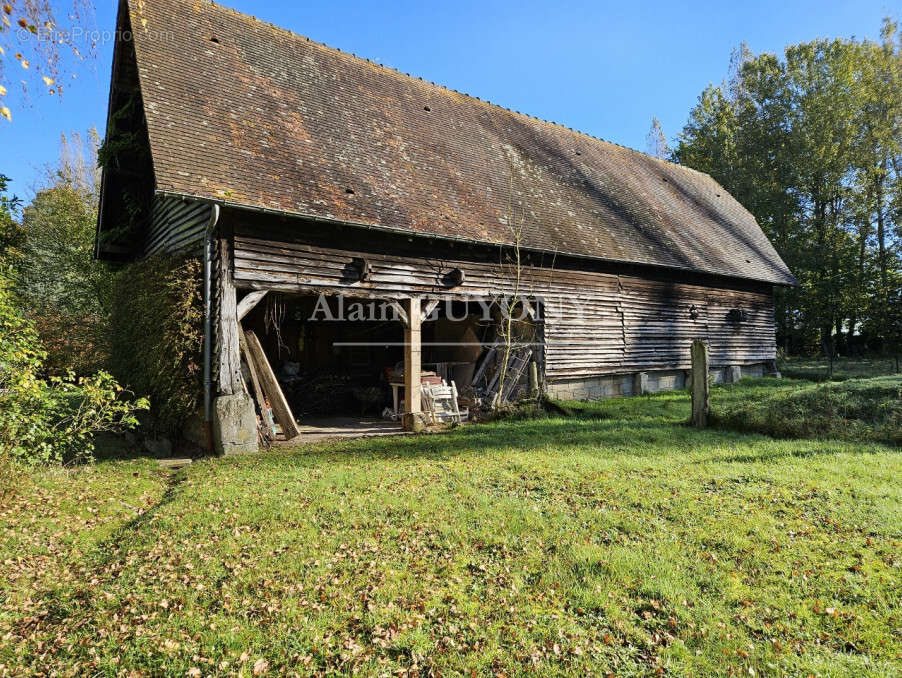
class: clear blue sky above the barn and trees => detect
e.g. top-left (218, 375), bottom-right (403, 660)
top-left (0, 0), bottom-right (902, 199)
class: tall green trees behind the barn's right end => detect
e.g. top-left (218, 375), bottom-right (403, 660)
top-left (673, 20), bottom-right (902, 370)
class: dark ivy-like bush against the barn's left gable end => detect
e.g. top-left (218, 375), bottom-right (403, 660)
top-left (110, 255), bottom-right (203, 435)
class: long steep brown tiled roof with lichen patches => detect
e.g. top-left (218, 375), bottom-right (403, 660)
top-left (122, 0), bottom-right (794, 283)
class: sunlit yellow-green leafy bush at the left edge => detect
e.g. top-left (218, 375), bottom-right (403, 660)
top-left (0, 278), bottom-right (148, 468)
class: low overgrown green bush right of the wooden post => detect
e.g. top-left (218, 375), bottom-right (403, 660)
top-left (711, 376), bottom-right (902, 445)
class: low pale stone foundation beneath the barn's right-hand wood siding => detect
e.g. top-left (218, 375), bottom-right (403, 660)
top-left (547, 363), bottom-right (774, 400)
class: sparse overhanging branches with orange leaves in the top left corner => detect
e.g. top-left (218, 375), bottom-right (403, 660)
top-left (0, 0), bottom-right (97, 120)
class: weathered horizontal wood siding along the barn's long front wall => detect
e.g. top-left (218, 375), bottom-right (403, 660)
top-left (234, 231), bottom-right (775, 380)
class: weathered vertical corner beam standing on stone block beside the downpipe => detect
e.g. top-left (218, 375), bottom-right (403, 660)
top-left (215, 238), bottom-right (244, 395)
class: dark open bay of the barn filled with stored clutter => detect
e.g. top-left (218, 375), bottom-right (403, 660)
top-left (241, 292), bottom-right (542, 434)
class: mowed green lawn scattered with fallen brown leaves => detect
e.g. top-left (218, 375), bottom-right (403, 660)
top-left (0, 382), bottom-right (902, 676)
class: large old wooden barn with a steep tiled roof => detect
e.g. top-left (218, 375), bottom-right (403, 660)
top-left (97, 0), bottom-right (796, 452)
